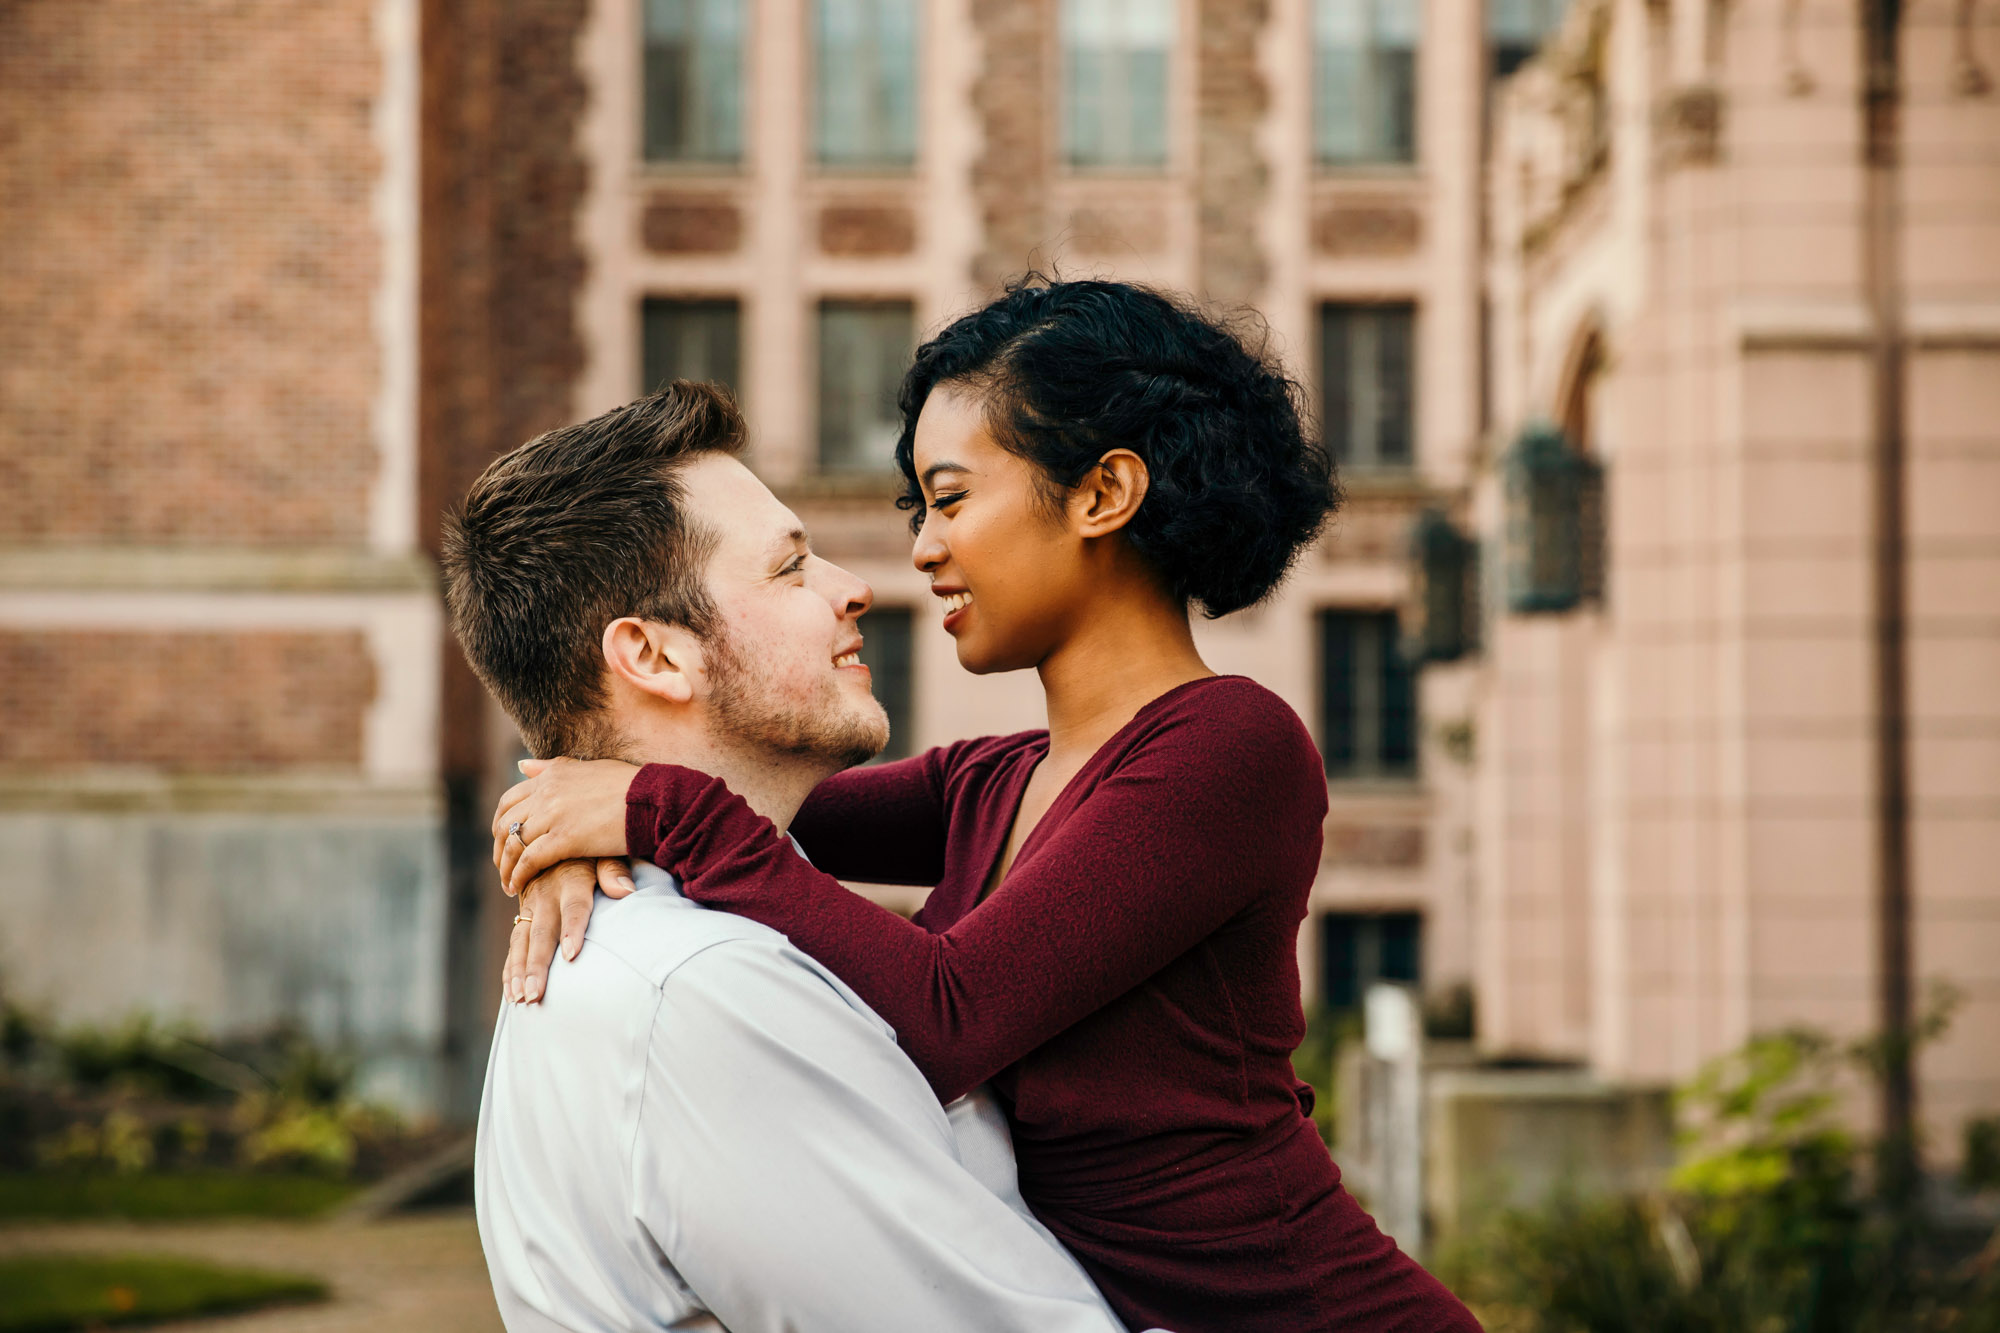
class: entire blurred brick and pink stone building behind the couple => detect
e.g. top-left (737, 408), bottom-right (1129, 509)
top-left (0, 0), bottom-right (2000, 1176)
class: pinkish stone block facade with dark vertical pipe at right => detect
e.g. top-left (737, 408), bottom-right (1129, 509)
top-left (1468, 0), bottom-right (2000, 1159)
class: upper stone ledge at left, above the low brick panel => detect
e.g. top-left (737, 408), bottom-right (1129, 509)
top-left (0, 546), bottom-right (438, 592)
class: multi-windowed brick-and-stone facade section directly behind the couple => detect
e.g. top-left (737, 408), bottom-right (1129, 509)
top-left (576, 0), bottom-right (1512, 1024)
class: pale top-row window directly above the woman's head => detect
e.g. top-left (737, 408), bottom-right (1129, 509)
top-left (1062, 0), bottom-right (1174, 168)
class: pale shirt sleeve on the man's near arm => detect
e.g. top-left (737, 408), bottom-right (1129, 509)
top-left (632, 943), bottom-right (1122, 1333)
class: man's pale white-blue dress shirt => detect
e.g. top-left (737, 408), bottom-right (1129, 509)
top-left (476, 863), bottom-right (1122, 1333)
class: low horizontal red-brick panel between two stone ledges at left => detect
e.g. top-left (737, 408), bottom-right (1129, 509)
top-left (0, 630), bottom-right (376, 773)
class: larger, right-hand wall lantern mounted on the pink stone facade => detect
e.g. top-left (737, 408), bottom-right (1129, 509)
top-left (1504, 424), bottom-right (1602, 614)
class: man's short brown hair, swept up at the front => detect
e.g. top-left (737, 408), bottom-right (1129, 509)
top-left (444, 380), bottom-right (744, 759)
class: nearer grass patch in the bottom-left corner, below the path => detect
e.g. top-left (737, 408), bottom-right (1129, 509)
top-left (0, 1255), bottom-right (326, 1333)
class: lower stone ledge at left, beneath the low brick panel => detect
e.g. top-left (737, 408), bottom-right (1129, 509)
top-left (0, 769), bottom-right (444, 821)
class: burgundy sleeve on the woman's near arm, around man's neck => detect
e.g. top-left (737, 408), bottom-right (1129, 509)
top-left (626, 684), bottom-right (1326, 1101)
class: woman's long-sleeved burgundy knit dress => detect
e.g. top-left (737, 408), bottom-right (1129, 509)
top-left (626, 677), bottom-right (1478, 1333)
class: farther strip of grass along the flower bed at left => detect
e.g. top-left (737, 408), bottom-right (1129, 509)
top-left (0, 1171), bottom-right (356, 1216)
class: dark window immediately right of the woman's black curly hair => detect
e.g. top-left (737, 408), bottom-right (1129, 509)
top-left (1320, 304), bottom-right (1416, 468)
